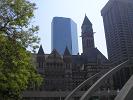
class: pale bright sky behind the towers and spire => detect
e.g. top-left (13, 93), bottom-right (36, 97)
top-left (31, 0), bottom-right (108, 57)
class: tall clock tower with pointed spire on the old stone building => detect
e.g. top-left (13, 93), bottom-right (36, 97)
top-left (81, 15), bottom-right (95, 53)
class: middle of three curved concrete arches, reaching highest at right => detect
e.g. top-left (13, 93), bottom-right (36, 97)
top-left (80, 60), bottom-right (129, 100)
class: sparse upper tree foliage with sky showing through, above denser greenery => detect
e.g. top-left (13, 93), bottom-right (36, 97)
top-left (0, 0), bottom-right (39, 50)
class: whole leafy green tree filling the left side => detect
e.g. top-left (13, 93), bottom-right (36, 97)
top-left (0, 0), bottom-right (42, 100)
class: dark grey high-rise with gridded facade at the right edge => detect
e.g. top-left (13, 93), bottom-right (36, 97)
top-left (101, 0), bottom-right (133, 89)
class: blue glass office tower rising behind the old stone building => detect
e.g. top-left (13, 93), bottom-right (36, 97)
top-left (51, 17), bottom-right (78, 55)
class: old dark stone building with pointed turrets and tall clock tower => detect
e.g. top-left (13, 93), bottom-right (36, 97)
top-left (24, 16), bottom-right (112, 100)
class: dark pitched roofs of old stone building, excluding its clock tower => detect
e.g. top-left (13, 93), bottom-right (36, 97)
top-left (36, 46), bottom-right (109, 64)
